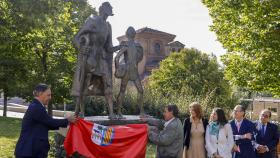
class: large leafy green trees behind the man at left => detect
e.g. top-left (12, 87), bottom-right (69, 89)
top-left (0, 0), bottom-right (96, 114)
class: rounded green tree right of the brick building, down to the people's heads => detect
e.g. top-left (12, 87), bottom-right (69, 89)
top-left (149, 48), bottom-right (234, 111)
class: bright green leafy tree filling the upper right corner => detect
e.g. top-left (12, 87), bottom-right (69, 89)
top-left (203, 0), bottom-right (280, 96)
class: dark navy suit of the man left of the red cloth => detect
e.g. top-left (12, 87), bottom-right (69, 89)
top-left (15, 99), bottom-right (68, 158)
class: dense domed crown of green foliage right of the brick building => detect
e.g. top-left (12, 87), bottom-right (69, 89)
top-left (149, 48), bottom-right (223, 95)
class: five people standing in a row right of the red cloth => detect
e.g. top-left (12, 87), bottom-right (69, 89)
top-left (146, 102), bottom-right (279, 158)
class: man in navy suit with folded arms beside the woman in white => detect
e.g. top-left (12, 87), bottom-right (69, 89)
top-left (230, 105), bottom-right (256, 158)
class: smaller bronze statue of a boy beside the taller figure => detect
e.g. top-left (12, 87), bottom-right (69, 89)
top-left (115, 27), bottom-right (144, 118)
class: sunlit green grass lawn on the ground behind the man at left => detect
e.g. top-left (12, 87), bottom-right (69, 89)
top-left (0, 116), bottom-right (156, 158)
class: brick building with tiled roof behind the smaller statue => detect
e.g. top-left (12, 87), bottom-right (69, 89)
top-left (117, 27), bottom-right (185, 79)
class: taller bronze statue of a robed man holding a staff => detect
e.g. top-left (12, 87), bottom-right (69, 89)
top-left (71, 2), bottom-right (119, 119)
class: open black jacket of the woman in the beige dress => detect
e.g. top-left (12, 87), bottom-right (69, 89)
top-left (183, 118), bottom-right (208, 149)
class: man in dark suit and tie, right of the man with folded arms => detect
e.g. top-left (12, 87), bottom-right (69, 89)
top-left (255, 109), bottom-right (278, 158)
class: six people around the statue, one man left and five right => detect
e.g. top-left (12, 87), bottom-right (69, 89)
top-left (15, 84), bottom-right (279, 158)
